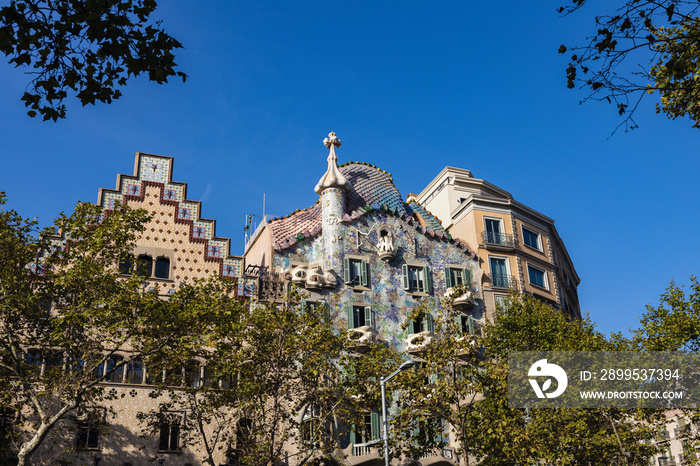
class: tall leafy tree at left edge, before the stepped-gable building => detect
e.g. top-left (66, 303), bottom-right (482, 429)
top-left (0, 194), bottom-right (190, 466)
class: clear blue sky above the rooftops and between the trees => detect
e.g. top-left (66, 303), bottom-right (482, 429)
top-left (0, 1), bottom-right (700, 332)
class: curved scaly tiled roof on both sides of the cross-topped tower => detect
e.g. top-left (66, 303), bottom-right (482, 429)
top-left (267, 162), bottom-right (451, 250)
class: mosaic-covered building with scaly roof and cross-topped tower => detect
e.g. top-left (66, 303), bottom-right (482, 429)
top-left (244, 133), bottom-right (485, 466)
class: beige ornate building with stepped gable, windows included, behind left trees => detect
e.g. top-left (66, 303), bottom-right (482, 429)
top-left (26, 153), bottom-right (243, 466)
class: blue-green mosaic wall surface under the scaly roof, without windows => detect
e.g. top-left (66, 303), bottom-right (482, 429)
top-left (274, 211), bottom-right (482, 347)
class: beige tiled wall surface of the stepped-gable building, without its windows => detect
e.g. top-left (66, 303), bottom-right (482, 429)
top-left (26, 153), bottom-right (244, 466)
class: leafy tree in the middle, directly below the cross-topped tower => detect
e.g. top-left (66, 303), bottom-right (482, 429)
top-left (141, 287), bottom-right (374, 466)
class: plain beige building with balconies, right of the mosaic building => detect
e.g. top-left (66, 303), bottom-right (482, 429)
top-left (416, 167), bottom-right (581, 318)
